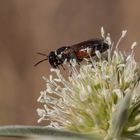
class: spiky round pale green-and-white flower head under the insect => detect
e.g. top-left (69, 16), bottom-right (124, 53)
top-left (37, 28), bottom-right (140, 139)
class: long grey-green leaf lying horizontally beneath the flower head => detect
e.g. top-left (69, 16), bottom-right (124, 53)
top-left (0, 125), bottom-right (99, 140)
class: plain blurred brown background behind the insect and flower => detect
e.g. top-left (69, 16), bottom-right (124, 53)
top-left (0, 0), bottom-right (140, 139)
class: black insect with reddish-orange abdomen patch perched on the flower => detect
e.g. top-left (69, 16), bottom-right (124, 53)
top-left (35, 39), bottom-right (109, 69)
